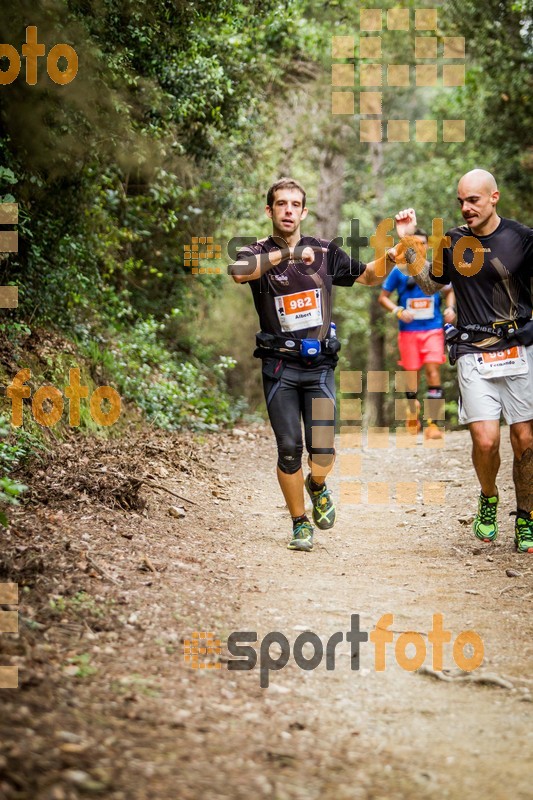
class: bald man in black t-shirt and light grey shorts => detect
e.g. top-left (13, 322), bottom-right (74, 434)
top-left (396, 169), bottom-right (533, 553)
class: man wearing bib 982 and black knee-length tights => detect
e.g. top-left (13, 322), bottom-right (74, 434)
top-left (229, 178), bottom-right (412, 551)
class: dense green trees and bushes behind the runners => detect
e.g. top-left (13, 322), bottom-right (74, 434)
top-left (0, 0), bottom-right (533, 520)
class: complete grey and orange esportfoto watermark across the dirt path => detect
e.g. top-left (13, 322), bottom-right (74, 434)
top-left (184, 614), bottom-right (485, 689)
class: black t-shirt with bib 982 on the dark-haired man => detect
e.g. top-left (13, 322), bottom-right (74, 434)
top-left (236, 236), bottom-right (366, 339)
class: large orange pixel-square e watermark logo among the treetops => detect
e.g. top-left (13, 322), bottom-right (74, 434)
top-left (331, 7), bottom-right (466, 144)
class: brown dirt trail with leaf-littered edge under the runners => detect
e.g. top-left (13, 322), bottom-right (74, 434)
top-left (0, 428), bottom-right (533, 800)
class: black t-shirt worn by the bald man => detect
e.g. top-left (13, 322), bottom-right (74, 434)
top-left (430, 218), bottom-right (533, 355)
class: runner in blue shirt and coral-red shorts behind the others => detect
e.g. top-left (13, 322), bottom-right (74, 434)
top-left (378, 228), bottom-right (455, 439)
